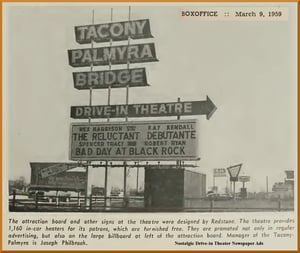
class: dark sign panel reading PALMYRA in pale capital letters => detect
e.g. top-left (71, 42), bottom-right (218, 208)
top-left (68, 43), bottom-right (158, 67)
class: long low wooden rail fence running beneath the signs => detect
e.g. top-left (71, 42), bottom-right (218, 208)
top-left (9, 192), bottom-right (294, 212)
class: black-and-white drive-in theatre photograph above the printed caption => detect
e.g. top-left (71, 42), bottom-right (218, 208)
top-left (3, 3), bottom-right (297, 249)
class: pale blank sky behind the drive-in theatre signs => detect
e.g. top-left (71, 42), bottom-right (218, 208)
top-left (3, 3), bottom-right (297, 194)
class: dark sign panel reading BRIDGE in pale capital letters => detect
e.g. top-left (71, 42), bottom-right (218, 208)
top-left (73, 68), bottom-right (148, 90)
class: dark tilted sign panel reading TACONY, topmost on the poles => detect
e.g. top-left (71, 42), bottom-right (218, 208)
top-left (75, 19), bottom-right (153, 44)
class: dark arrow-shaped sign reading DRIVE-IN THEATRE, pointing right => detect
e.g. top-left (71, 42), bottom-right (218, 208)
top-left (71, 96), bottom-right (217, 119)
